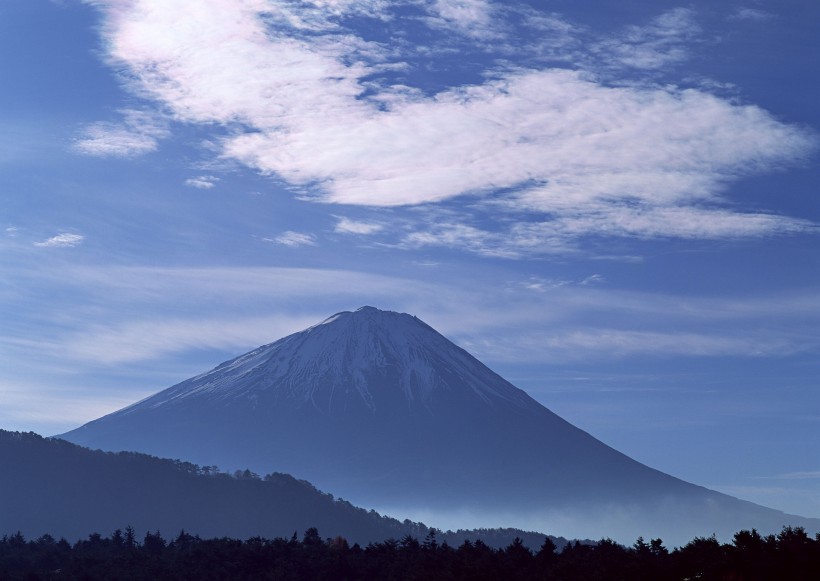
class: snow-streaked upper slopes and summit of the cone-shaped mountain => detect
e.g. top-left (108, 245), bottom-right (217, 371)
top-left (119, 307), bottom-right (532, 414)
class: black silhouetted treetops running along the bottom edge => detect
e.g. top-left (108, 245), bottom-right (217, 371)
top-left (0, 527), bottom-right (820, 581)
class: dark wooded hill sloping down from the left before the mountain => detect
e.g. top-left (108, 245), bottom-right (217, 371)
top-left (0, 430), bottom-right (565, 548)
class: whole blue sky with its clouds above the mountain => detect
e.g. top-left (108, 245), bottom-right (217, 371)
top-left (0, 0), bottom-right (820, 517)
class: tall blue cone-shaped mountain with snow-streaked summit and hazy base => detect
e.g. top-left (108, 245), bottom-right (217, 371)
top-left (61, 307), bottom-right (820, 542)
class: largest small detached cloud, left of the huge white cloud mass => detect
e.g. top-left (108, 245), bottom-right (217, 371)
top-left (73, 110), bottom-right (169, 157)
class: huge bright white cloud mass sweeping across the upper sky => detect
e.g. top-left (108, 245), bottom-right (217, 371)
top-left (86, 0), bottom-right (816, 247)
